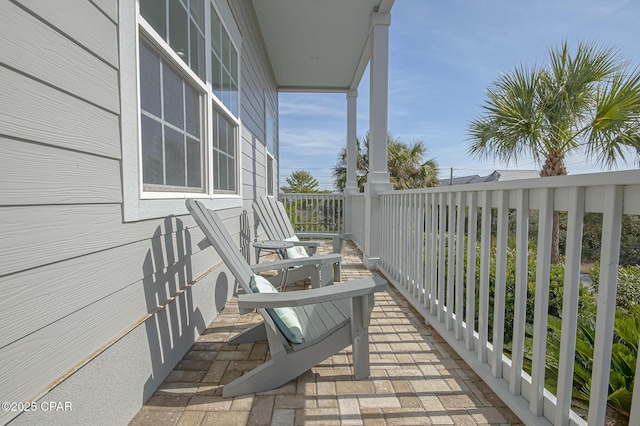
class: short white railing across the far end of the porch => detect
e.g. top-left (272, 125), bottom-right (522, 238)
top-left (279, 192), bottom-right (344, 233)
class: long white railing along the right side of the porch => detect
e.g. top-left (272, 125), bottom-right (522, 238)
top-left (376, 171), bottom-right (640, 425)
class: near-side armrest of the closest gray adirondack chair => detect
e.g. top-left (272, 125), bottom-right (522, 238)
top-left (238, 277), bottom-right (388, 309)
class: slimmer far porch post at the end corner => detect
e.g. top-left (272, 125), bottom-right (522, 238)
top-left (344, 90), bottom-right (360, 236)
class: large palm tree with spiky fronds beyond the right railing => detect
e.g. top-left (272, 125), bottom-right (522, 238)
top-left (468, 41), bottom-right (640, 263)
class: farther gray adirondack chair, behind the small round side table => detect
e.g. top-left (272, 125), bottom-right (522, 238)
top-left (253, 197), bottom-right (351, 282)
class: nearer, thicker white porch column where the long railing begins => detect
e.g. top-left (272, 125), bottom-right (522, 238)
top-left (363, 13), bottom-right (393, 269)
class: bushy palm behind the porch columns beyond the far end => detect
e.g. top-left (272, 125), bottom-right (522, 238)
top-left (333, 133), bottom-right (440, 192)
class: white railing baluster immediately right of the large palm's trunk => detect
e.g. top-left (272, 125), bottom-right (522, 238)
top-left (554, 187), bottom-right (584, 426)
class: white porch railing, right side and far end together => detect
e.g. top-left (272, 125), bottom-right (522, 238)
top-left (282, 170), bottom-right (640, 425)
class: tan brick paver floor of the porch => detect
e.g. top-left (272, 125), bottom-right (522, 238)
top-left (130, 243), bottom-right (521, 426)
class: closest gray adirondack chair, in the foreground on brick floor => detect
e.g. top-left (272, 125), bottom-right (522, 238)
top-left (186, 200), bottom-right (387, 397)
